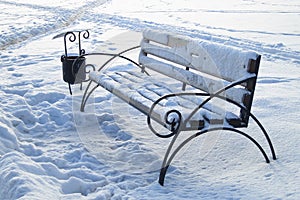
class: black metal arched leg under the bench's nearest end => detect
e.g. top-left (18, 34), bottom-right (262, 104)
top-left (159, 127), bottom-right (270, 186)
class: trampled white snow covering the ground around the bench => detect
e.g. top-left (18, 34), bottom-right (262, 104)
top-left (0, 0), bottom-right (300, 200)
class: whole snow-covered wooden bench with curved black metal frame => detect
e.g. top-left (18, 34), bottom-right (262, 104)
top-left (81, 30), bottom-right (276, 185)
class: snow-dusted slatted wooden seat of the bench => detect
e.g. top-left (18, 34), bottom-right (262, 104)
top-left (90, 70), bottom-right (240, 130)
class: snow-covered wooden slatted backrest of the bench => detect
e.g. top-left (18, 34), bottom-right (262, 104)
top-left (139, 30), bottom-right (260, 126)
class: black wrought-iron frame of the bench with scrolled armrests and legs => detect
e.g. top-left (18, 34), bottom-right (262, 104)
top-left (74, 29), bottom-right (276, 185)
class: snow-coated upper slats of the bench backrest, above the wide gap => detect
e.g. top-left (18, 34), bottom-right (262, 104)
top-left (140, 30), bottom-right (258, 82)
